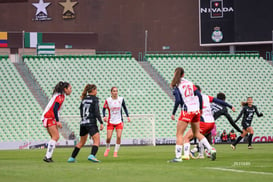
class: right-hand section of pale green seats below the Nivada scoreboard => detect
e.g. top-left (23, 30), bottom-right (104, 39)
top-left (146, 54), bottom-right (273, 136)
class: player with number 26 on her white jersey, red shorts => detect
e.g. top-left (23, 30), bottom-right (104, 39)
top-left (170, 67), bottom-right (216, 162)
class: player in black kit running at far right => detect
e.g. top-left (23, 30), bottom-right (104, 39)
top-left (230, 97), bottom-right (263, 150)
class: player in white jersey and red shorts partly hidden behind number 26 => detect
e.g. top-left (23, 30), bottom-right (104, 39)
top-left (182, 85), bottom-right (235, 160)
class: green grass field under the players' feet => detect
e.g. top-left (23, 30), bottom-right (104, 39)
top-left (0, 144), bottom-right (273, 182)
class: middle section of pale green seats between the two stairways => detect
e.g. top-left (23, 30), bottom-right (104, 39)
top-left (24, 55), bottom-right (176, 138)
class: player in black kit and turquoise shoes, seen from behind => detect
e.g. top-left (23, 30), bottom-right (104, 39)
top-left (68, 84), bottom-right (103, 162)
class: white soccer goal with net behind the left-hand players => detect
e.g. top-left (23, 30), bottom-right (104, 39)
top-left (60, 114), bottom-right (156, 146)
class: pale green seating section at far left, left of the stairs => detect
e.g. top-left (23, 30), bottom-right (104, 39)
top-left (0, 56), bottom-right (48, 142)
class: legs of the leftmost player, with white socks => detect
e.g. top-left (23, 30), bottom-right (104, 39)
top-left (43, 125), bottom-right (60, 162)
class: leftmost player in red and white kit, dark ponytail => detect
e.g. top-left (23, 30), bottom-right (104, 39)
top-left (41, 82), bottom-right (72, 162)
